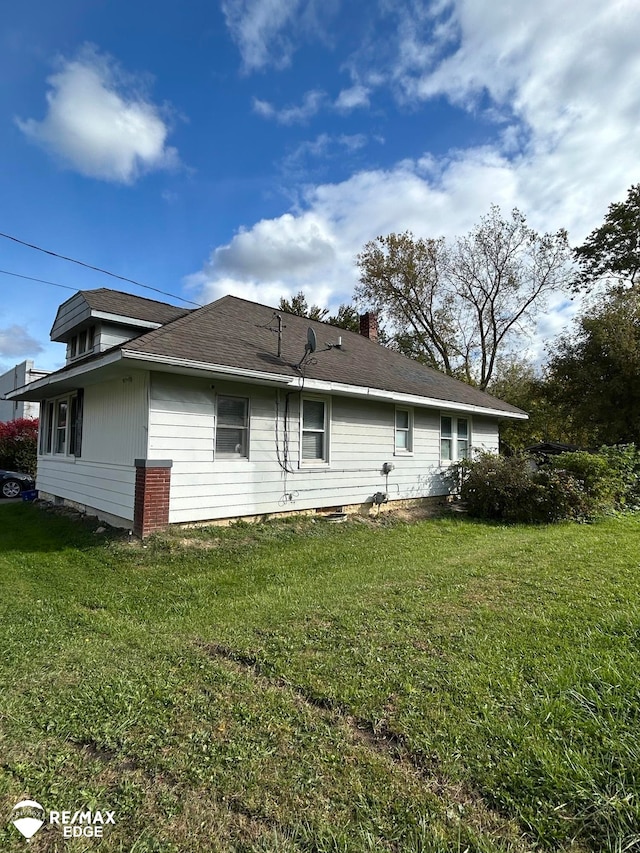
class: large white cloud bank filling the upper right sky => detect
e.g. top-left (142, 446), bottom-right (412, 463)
top-left (192, 0), bottom-right (640, 358)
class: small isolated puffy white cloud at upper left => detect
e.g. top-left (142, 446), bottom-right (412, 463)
top-left (16, 47), bottom-right (178, 184)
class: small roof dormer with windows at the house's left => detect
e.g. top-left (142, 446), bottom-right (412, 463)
top-left (51, 288), bottom-right (189, 364)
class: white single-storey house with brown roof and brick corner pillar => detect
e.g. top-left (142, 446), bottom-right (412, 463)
top-left (10, 289), bottom-right (527, 536)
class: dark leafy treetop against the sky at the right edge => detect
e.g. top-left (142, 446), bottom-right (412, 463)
top-left (575, 184), bottom-right (640, 289)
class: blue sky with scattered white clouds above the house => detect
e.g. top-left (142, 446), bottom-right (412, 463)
top-left (0, 0), bottom-right (640, 371)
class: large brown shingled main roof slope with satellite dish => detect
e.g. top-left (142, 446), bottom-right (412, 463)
top-left (122, 296), bottom-right (524, 415)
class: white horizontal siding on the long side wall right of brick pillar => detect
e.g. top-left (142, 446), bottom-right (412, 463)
top-left (148, 374), bottom-right (470, 523)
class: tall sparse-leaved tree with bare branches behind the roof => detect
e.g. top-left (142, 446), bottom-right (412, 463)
top-left (355, 205), bottom-right (571, 390)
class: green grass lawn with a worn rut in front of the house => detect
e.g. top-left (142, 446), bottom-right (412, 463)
top-left (0, 503), bottom-right (640, 853)
